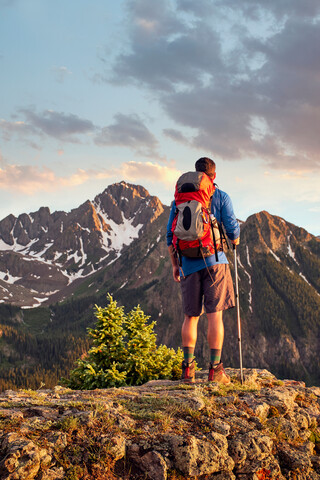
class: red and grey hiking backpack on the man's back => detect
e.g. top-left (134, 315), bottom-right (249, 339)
top-left (171, 172), bottom-right (223, 264)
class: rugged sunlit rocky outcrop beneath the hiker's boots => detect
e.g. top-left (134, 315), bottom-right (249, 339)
top-left (0, 369), bottom-right (320, 480)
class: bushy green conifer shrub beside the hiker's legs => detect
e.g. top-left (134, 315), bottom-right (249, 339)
top-left (63, 294), bottom-right (183, 390)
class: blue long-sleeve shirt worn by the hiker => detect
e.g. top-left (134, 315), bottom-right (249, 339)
top-left (167, 188), bottom-right (240, 276)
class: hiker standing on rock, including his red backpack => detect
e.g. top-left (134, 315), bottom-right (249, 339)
top-left (167, 157), bottom-right (240, 384)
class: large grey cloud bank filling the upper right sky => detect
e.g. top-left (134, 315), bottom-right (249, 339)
top-left (106, 0), bottom-right (320, 170)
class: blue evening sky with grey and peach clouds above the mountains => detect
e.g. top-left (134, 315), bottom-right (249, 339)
top-left (0, 0), bottom-right (320, 235)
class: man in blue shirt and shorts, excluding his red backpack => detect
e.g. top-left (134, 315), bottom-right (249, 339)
top-left (167, 157), bottom-right (240, 384)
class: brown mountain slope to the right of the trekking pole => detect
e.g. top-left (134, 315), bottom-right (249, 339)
top-left (235, 212), bottom-right (320, 383)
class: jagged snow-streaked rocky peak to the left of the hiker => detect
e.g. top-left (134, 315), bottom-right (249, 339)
top-left (0, 182), bottom-right (163, 306)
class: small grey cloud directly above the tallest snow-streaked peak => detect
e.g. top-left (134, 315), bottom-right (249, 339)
top-left (95, 113), bottom-right (158, 156)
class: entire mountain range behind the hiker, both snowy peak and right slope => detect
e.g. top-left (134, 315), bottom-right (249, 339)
top-left (0, 182), bottom-right (320, 388)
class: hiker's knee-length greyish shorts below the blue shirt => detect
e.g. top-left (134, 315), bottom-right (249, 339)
top-left (180, 263), bottom-right (235, 317)
